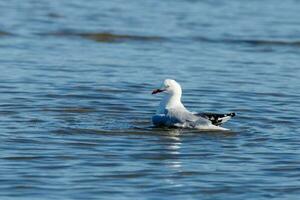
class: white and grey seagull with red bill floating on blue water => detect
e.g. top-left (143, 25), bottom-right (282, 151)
top-left (152, 79), bottom-right (235, 130)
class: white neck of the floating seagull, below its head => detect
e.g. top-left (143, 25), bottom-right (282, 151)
top-left (157, 92), bottom-right (184, 114)
